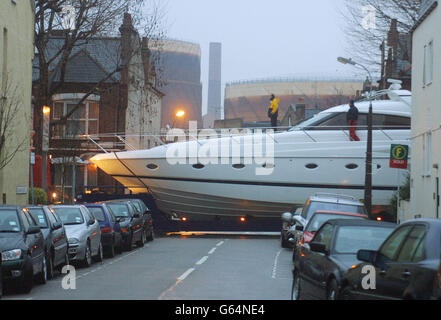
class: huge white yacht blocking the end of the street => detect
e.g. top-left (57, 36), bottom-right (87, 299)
top-left (91, 85), bottom-right (411, 219)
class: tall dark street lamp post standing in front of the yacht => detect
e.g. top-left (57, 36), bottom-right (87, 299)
top-left (337, 57), bottom-right (373, 217)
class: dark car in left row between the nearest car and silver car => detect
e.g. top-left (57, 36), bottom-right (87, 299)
top-left (26, 206), bottom-right (69, 279)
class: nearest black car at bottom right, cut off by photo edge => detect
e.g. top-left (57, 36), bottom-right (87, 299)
top-left (343, 219), bottom-right (441, 300)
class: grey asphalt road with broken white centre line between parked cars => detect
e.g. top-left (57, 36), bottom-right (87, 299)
top-left (3, 234), bottom-right (292, 300)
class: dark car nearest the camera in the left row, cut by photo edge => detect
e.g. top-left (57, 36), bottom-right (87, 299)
top-left (0, 205), bottom-right (47, 293)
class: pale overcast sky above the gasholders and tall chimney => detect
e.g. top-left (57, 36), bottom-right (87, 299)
top-left (162, 0), bottom-right (354, 113)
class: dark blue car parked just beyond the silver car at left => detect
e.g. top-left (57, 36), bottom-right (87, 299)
top-left (85, 203), bottom-right (123, 258)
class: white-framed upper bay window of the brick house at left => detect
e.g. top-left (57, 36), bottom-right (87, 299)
top-left (52, 94), bottom-right (99, 138)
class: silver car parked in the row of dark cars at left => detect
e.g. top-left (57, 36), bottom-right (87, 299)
top-left (52, 205), bottom-right (103, 267)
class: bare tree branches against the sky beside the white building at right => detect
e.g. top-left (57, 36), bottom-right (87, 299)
top-left (340, 0), bottom-right (423, 73)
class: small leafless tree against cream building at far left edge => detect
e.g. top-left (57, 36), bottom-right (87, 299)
top-left (0, 80), bottom-right (29, 170)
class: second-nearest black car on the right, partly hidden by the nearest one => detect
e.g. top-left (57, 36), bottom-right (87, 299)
top-left (292, 219), bottom-right (396, 300)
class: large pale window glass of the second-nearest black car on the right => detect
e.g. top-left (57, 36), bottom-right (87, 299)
top-left (335, 226), bottom-right (394, 254)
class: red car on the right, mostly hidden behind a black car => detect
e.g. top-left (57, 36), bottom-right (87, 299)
top-left (289, 210), bottom-right (368, 261)
